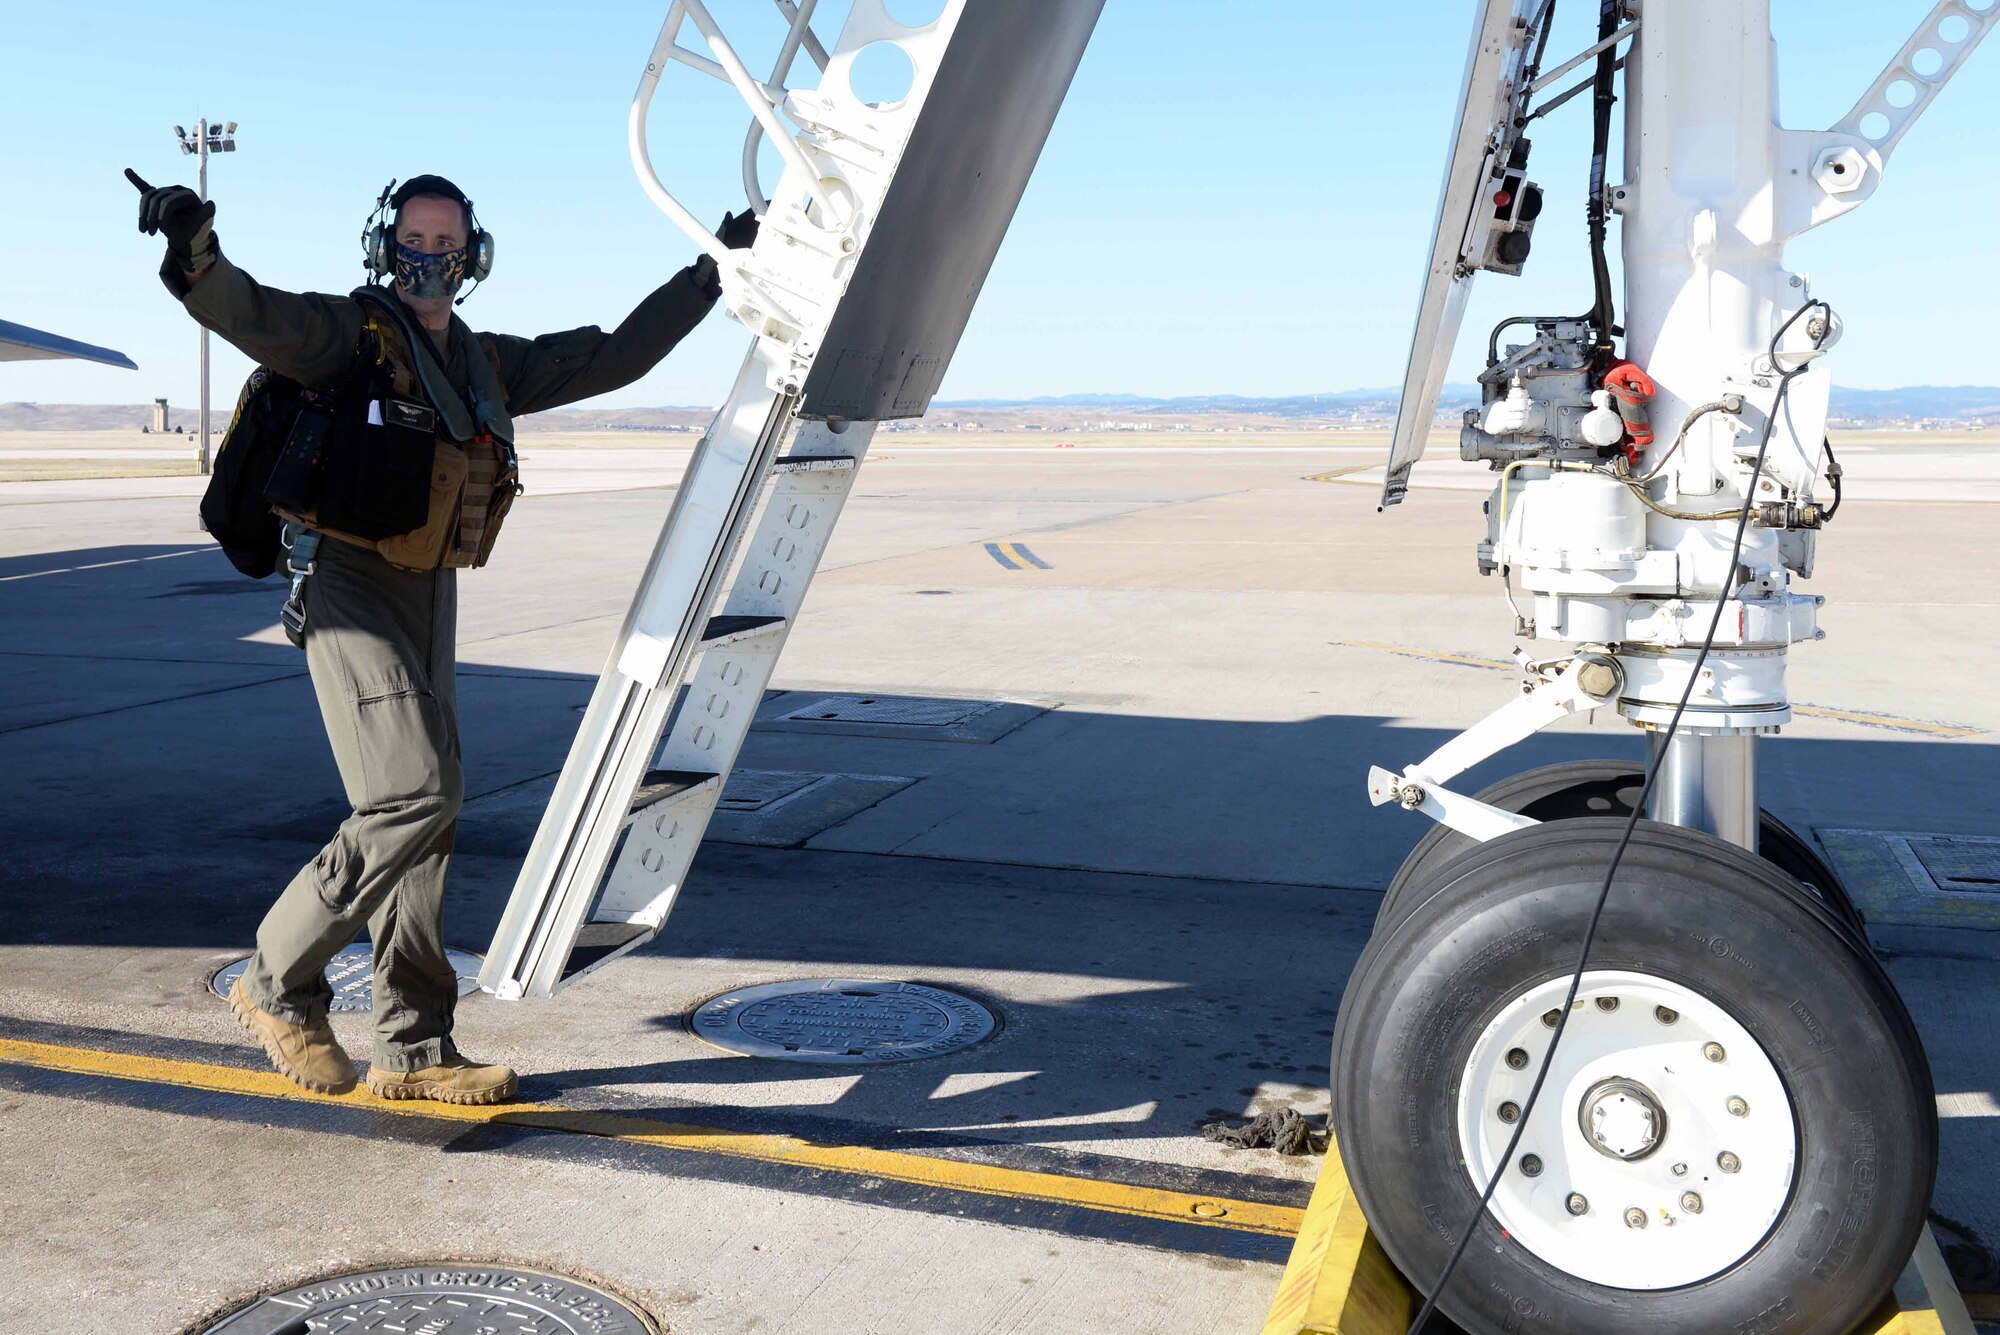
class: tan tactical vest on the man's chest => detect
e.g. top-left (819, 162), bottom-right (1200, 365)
top-left (278, 299), bottom-right (522, 570)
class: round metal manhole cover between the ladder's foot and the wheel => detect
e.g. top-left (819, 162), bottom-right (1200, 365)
top-left (694, 977), bottom-right (1000, 1065)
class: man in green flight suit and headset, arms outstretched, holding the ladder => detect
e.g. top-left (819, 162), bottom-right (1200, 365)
top-left (126, 172), bottom-right (756, 1103)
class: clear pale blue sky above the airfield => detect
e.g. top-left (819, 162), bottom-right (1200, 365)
top-left (0, 0), bottom-right (2000, 408)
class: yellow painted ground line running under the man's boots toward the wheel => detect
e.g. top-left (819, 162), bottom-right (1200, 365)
top-left (0, 1039), bottom-right (1306, 1237)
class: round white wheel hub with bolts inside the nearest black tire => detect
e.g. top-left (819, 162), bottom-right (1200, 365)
top-left (1458, 969), bottom-right (1798, 1289)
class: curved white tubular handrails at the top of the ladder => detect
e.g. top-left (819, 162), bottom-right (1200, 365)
top-left (626, 0), bottom-right (838, 268)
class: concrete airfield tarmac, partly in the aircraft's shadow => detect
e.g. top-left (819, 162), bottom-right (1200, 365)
top-left (0, 436), bottom-right (2000, 1335)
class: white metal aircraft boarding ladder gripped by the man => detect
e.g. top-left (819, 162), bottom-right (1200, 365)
top-left (480, 0), bottom-right (1102, 999)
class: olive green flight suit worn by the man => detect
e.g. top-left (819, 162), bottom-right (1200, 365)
top-left (172, 254), bottom-right (716, 1071)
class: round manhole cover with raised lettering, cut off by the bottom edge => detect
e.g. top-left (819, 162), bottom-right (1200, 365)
top-left (202, 1261), bottom-right (658, 1335)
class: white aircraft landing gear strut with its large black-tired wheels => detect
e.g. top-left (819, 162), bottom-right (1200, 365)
top-left (1332, 0), bottom-right (2000, 1335)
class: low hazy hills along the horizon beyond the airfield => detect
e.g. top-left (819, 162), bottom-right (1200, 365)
top-left (0, 384), bottom-right (2000, 434)
